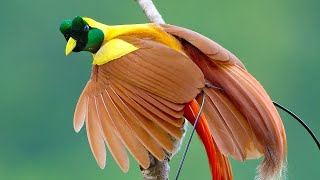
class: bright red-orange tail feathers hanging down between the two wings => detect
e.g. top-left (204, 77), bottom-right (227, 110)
top-left (184, 100), bottom-right (232, 180)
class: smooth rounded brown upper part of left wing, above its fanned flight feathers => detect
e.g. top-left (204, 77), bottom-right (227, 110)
top-left (102, 37), bottom-right (204, 104)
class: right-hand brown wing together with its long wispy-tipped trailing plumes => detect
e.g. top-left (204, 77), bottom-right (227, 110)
top-left (162, 25), bottom-right (286, 178)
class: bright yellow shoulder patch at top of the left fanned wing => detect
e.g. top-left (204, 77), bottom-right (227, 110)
top-left (93, 39), bottom-right (138, 65)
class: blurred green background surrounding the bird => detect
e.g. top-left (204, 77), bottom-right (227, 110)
top-left (0, 0), bottom-right (320, 180)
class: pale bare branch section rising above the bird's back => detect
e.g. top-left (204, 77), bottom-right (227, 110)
top-left (137, 0), bottom-right (165, 24)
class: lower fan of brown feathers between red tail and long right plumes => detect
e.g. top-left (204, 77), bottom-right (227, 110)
top-left (204, 88), bottom-right (262, 161)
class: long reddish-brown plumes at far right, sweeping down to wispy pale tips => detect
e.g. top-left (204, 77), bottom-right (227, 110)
top-left (222, 66), bottom-right (287, 179)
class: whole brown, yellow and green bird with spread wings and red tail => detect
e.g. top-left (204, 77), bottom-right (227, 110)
top-left (60, 16), bottom-right (287, 180)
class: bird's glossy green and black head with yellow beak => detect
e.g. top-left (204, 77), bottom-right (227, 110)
top-left (60, 16), bottom-right (104, 55)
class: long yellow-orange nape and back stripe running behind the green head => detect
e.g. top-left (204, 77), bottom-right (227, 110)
top-left (83, 18), bottom-right (183, 53)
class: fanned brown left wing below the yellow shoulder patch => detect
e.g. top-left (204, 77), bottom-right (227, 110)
top-left (74, 37), bottom-right (204, 172)
